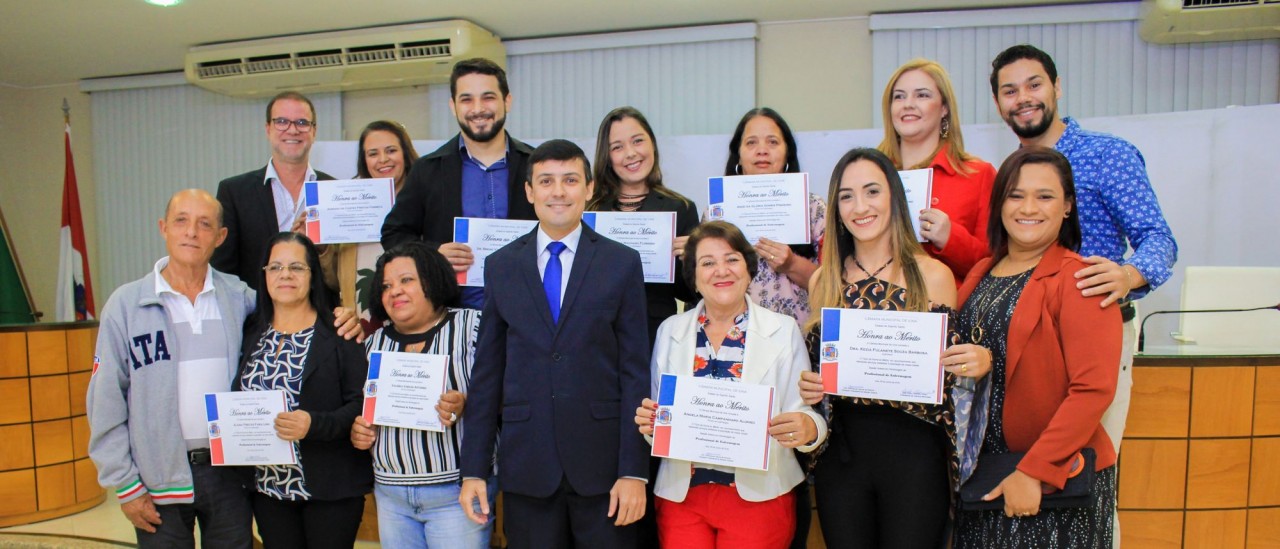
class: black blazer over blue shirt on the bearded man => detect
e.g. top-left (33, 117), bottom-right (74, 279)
top-left (383, 134), bottom-right (538, 250)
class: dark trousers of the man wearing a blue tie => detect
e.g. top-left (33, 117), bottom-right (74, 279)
top-left (502, 481), bottom-right (639, 549)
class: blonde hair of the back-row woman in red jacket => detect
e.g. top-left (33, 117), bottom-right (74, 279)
top-left (877, 58), bottom-right (973, 175)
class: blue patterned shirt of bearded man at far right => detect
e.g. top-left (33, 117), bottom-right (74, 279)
top-left (1053, 116), bottom-right (1178, 301)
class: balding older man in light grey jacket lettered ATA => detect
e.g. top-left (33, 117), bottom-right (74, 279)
top-left (87, 189), bottom-right (360, 549)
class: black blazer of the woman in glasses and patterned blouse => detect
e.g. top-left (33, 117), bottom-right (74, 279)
top-left (233, 315), bottom-right (374, 500)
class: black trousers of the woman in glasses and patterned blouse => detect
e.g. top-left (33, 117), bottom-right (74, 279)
top-left (253, 494), bottom-right (365, 549)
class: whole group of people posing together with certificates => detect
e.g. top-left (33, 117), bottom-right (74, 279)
top-left (88, 45), bottom-right (1176, 548)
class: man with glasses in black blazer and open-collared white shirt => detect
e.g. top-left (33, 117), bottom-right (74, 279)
top-left (210, 91), bottom-right (337, 292)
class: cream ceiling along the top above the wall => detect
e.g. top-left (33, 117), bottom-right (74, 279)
top-left (0, 0), bottom-right (1097, 87)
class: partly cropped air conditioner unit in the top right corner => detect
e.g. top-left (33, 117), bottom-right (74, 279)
top-left (1138, 0), bottom-right (1280, 44)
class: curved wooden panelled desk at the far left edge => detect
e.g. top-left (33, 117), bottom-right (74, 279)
top-left (0, 322), bottom-right (105, 526)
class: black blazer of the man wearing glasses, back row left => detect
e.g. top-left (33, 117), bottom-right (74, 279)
top-left (209, 166), bottom-right (333, 290)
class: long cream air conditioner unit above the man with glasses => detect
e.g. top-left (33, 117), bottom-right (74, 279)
top-left (186, 20), bottom-right (507, 97)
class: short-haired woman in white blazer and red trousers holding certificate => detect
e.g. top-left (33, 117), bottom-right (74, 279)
top-left (636, 221), bottom-right (827, 549)
